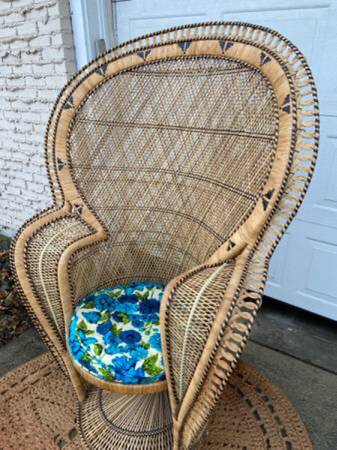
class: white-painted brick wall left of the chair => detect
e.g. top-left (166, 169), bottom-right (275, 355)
top-left (0, 0), bottom-right (75, 235)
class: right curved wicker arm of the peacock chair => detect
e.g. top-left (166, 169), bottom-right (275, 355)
top-left (161, 249), bottom-right (250, 448)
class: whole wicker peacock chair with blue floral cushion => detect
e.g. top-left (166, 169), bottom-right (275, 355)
top-left (12, 23), bottom-right (319, 450)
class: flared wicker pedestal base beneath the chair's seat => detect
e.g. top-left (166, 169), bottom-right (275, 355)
top-left (78, 389), bottom-right (173, 450)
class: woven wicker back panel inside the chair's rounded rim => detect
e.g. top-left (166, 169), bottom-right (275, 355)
top-left (68, 56), bottom-right (278, 296)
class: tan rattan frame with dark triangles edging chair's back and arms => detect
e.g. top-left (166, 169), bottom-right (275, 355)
top-left (12, 22), bottom-right (319, 449)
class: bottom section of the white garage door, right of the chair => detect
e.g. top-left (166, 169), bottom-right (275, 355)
top-left (266, 221), bottom-right (337, 319)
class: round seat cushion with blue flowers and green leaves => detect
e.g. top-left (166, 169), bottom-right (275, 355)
top-left (68, 282), bottom-right (165, 384)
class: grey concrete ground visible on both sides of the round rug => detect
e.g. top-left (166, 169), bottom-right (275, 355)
top-left (0, 298), bottom-right (337, 450)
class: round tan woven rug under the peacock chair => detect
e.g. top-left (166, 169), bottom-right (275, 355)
top-left (0, 353), bottom-right (312, 450)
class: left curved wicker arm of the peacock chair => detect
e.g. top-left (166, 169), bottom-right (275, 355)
top-left (11, 206), bottom-right (93, 397)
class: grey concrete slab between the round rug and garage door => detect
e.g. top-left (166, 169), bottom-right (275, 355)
top-left (242, 342), bottom-right (337, 450)
